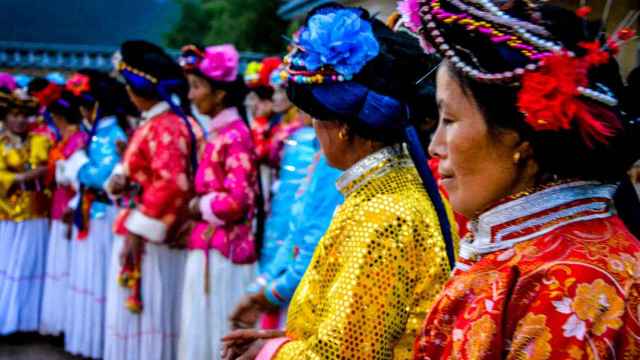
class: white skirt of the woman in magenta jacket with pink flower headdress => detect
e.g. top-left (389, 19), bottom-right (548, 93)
top-left (178, 250), bottom-right (255, 360)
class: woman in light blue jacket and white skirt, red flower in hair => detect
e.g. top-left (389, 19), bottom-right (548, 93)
top-left (65, 71), bottom-right (127, 359)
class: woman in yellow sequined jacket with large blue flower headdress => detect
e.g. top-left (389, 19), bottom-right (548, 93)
top-left (226, 4), bottom-right (451, 359)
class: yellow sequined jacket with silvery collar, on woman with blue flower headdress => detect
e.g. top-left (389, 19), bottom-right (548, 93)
top-left (275, 146), bottom-right (450, 360)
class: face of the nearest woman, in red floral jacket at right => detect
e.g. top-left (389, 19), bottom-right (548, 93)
top-left (429, 63), bottom-right (537, 218)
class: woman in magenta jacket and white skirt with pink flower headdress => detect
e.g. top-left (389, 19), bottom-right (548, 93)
top-left (179, 45), bottom-right (257, 359)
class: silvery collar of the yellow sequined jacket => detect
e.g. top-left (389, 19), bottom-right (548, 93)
top-left (336, 145), bottom-right (411, 197)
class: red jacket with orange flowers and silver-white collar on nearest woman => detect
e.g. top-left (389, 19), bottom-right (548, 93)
top-left (415, 182), bottom-right (640, 360)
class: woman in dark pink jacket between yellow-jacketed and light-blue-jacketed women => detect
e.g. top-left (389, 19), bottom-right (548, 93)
top-left (40, 92), bottom-right (88, 335)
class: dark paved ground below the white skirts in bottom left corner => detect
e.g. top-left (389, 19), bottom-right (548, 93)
top-left (0, 334), bottom-right (81, 360)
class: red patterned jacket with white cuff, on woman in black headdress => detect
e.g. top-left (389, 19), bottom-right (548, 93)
top-left (114, 102), bottom-right (203, 245)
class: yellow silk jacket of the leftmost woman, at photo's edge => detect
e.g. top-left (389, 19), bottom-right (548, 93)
top-left (0, 131), bottom-right (51, 221)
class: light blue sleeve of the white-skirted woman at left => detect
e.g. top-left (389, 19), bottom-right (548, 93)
top-left (78, 126), bottom-right (127, 190)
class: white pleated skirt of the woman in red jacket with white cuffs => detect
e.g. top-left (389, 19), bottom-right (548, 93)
top-left (104, 236), bottom-right (187, 360)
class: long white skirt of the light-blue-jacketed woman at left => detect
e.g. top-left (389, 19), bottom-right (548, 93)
top-left (64, 206), bottom-right (117, 359)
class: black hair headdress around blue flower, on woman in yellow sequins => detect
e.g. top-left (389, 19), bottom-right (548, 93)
top-left (287, 3), bottom-right (433, 145)
